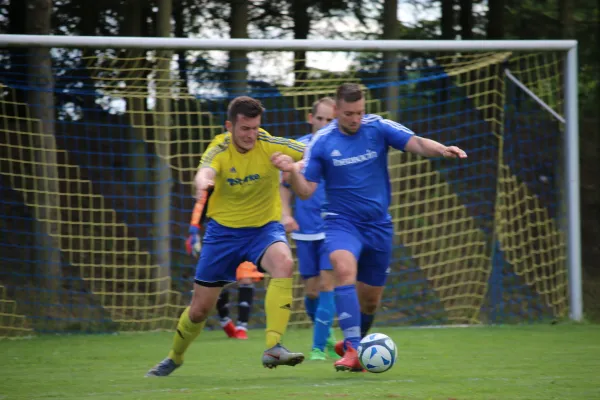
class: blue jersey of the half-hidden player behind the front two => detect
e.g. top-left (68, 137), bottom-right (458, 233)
top-left (291, 134), bottom-right (325, 240)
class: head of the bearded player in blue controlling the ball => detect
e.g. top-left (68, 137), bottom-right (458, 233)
top-left (335, 83), bottom-right (365, 133)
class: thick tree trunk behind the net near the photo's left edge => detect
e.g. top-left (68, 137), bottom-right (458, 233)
top-left (27, 0), bottom-right (61, 314)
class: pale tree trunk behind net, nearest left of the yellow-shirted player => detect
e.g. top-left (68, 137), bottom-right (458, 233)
top-left (152, 0), bottom-right (173, 303)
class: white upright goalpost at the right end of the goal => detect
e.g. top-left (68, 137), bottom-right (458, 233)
top-left (563, 46), bottom-right (583, 321)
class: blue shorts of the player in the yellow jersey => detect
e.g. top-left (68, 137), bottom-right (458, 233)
top-left (195, 220), bottom-right (287, 287)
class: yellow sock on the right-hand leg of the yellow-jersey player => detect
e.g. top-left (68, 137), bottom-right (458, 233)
top-left (265, 278), bottom-right (292, 349)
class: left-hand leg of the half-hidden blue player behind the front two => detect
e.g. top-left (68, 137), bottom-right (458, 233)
top-left (296, 240), bottom-right (319, 323)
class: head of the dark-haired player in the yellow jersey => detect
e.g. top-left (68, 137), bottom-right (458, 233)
top-left (225, 96), bottom-right (264, 153)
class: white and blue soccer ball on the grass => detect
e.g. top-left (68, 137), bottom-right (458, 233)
top-left (356, 333), bottom-right (396, 374)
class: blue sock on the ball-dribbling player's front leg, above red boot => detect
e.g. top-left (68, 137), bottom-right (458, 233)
top-left (335, 285), bottom-right (360, 349)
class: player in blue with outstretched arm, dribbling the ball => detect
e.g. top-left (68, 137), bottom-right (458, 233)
top-left (271, 83), bottom-right (467, 372)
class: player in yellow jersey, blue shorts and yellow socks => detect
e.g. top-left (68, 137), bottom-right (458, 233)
top-left (146, 96), bottom-right (304, 376)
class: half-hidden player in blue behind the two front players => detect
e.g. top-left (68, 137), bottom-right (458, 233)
top-left (280, 97), bottom-right (339, 360)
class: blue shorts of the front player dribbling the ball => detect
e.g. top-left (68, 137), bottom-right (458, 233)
top-left (325, 215), bottom-right (394, 286)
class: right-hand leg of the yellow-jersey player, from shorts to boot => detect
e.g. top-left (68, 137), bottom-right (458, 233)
top-left (248, 222), bottom-right (304, 368)
